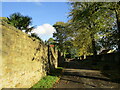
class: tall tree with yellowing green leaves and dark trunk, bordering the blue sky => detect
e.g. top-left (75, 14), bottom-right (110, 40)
top-left (70, 2), bottom-right (115, 55)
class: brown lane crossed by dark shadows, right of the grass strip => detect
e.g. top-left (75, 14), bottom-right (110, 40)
top-left (53, 61), bottom-right (120, 90)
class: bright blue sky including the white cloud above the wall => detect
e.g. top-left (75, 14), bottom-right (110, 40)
top-left (0, 2), bottom-right (70, 41)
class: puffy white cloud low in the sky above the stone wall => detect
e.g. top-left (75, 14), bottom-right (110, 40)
top-left (32, 24), bottom-right (56, 40)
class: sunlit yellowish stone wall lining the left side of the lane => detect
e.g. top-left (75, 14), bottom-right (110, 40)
top-left (0, 19), bottom-right (57, 89)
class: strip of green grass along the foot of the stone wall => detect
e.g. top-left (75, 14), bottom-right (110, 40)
top-left (32, 67), bottom-right (63, 89)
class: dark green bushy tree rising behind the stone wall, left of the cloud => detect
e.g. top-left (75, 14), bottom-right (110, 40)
top-left (7, 13), bottom-right (34, 33)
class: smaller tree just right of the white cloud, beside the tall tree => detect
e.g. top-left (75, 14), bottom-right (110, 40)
top-left (53, 22), bottom-right (77, 57)
